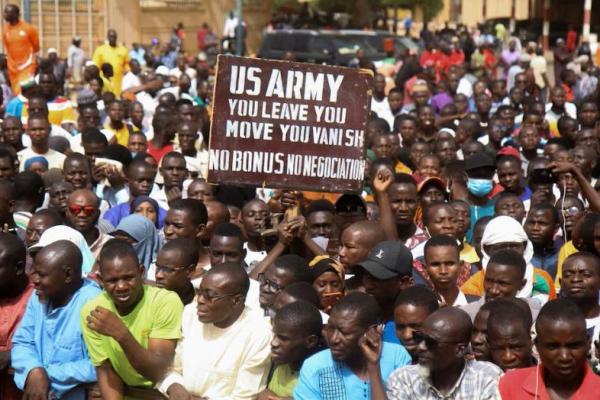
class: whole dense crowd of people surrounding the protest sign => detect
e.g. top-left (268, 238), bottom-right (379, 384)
top-left (0, 5), bottom-right (600, 400)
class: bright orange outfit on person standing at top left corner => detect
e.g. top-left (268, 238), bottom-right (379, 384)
top-left (2, 21), bottom-right (40, 95)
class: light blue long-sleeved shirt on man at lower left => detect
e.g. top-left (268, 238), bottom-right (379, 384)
top-left (11, 279), bottom-right (101, 400)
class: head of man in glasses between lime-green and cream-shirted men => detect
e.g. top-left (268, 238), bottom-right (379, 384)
top-left (155, 238), bottom-right (198, 305)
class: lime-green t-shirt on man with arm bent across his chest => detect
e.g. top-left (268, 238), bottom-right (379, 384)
top-left (81, 285), bottom-right (183, 388)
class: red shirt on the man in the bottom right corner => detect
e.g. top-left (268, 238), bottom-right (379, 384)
top-left (498, 363), bottom-right (600, 400)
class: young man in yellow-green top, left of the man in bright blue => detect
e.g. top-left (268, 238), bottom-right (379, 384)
top-left (258, 301), bottom-right (323, 400)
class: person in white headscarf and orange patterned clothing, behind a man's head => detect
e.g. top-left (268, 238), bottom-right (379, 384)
top-left (460, 216), bottom-right (556, 304)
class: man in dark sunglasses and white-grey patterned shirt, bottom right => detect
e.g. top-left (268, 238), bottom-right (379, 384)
top-left (380, 307), bottom-right (502, 400)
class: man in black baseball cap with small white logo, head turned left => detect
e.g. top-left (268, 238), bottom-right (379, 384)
top-left (356, 241), bottom-right (414, 343)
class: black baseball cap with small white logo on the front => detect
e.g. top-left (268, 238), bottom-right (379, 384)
top-left (357, 240), bottom-right (413, 279)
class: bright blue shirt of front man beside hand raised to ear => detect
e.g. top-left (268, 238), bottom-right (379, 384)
top-left (294, 342), bottom-right (411, 400)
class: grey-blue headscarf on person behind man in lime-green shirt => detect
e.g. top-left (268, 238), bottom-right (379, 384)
top-left (116, 214), bottom-right (160, 269)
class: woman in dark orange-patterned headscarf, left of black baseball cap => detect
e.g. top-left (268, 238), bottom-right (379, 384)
top-left (308, 256), bottom-right (345, 314)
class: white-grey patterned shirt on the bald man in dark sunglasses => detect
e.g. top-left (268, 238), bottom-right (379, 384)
top-left (386, 361), bottom-right (502, 400)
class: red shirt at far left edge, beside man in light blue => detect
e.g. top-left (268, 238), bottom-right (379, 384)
top-left (0, 283), bottom-right (33, 400)
